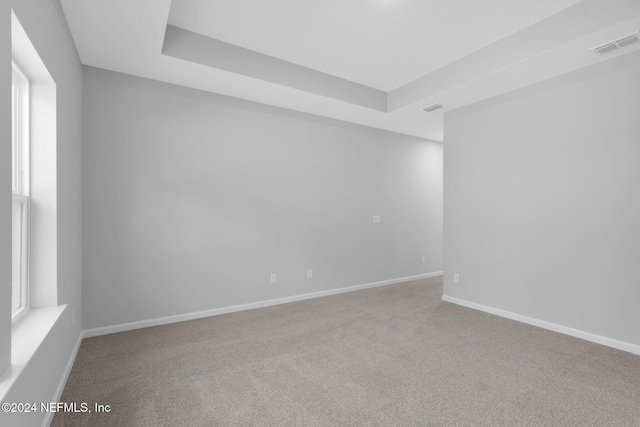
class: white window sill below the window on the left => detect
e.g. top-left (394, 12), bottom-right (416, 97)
top-left (0, 304), bottom-right (67, 401)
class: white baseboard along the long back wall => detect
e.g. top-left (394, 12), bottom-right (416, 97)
top-left (82, 271), bottom-right (442, 338)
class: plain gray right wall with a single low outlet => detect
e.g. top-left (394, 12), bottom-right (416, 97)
top-left (444, 52), bottom-right (640, 344)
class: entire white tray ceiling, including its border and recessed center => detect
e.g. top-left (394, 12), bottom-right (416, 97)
top-left (61, 0), bottom-right (640, 141)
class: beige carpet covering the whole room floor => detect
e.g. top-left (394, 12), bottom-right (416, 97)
top-left (53, 278), bottom-right (640, 427)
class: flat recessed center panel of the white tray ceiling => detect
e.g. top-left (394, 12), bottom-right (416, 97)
top-left (169, 0), bottom-right (580, 92)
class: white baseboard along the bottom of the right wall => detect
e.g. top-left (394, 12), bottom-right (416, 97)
top-left (442, 295), bottom-right (640, 355)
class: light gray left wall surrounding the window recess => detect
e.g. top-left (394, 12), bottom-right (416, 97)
top-left (0, 0), bottom-right (82, 425)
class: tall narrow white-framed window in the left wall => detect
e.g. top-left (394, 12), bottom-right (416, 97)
top-left (11, 62), bottom-right (29, 319)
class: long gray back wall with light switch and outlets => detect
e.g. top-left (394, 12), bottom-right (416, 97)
top-left (83, 68), bottom-right (442, 328)
